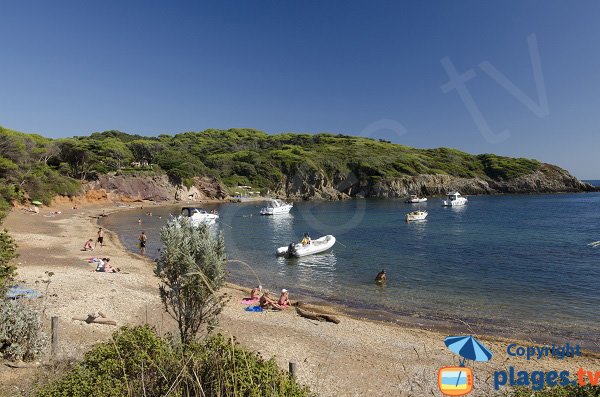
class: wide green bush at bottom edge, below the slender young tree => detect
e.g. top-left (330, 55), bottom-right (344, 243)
top-left (37, 326), bottom-right (310, 397)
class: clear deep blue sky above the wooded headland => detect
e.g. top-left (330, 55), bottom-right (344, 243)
top-left (0, 0), bottom-right (600, 179)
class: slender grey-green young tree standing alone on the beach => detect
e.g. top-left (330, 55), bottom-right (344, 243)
top-left (154, 219), bottom-right (226, 344)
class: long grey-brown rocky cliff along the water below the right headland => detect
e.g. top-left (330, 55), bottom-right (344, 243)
top-left (275, 164), bottom-right (597, 200)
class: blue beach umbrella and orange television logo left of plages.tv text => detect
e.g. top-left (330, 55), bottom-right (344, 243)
top-left (438, 336), bottom-right (492, 396)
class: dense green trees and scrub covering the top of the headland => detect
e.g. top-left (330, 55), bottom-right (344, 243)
top-left (0, 127), bottom-right (541, 212)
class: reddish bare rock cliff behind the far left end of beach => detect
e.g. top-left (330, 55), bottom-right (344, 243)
top-left (84, 175), bottom-right (227, 202)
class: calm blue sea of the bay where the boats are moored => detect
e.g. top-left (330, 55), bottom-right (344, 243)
top-left (101, 181), bottom-right (600, 351)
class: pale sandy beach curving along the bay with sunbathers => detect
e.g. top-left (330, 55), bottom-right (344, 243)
top-left (0, 203), bottom-right (600, 397)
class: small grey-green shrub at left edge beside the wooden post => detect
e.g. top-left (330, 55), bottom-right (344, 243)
top-left (0, 300), bottom-right (48, 361)
